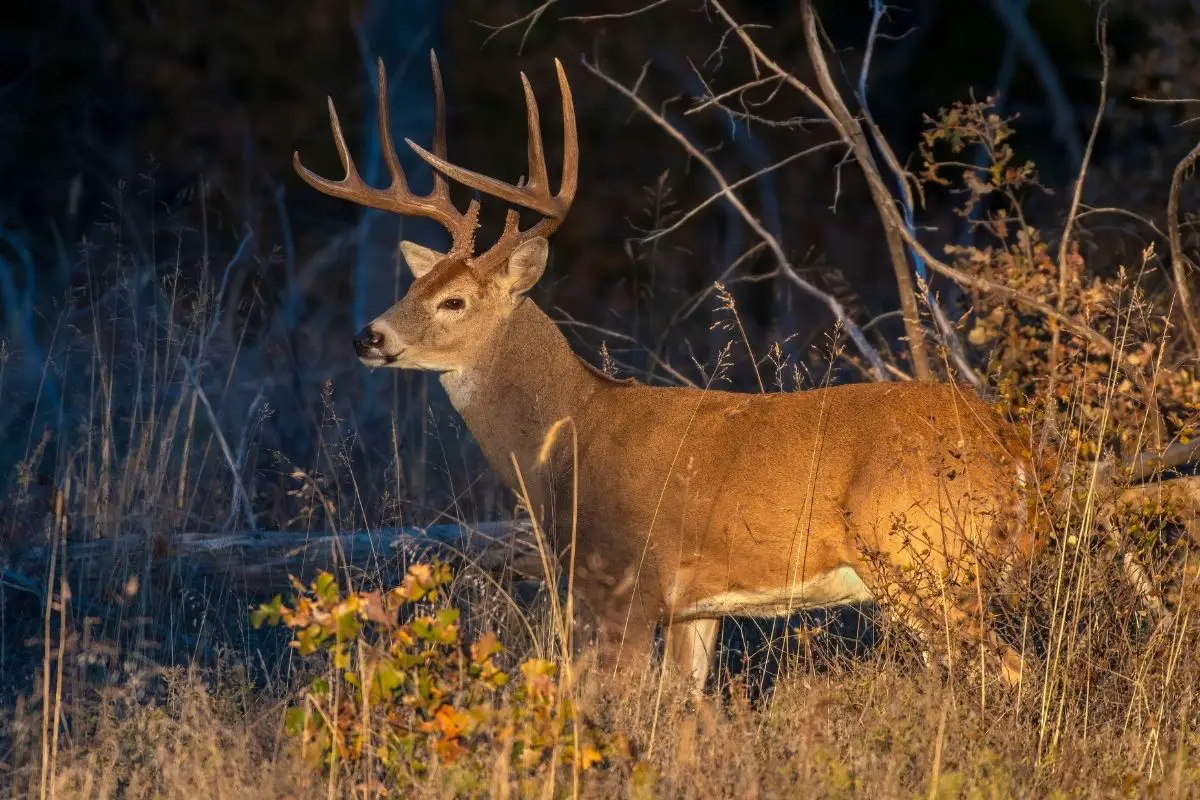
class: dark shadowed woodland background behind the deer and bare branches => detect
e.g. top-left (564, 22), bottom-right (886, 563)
top-left (0, 0), bottom-right (1200, 537)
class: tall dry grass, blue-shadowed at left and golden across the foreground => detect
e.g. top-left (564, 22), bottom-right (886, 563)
top-left (0, 159), bottom-right (1200, 798)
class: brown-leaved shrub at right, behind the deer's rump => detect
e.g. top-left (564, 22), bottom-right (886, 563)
top-left (919, 97), bottom-right (1200, 458)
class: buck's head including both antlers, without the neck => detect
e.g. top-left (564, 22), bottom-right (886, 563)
top-left (294, 52), bottom-right (580, 372)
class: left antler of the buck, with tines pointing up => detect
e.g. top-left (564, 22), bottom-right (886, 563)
top-left (293, 50), bottom-right (479, 258)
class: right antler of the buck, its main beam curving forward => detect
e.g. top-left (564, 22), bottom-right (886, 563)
top-left (404, 59), bottom-right (580, 273)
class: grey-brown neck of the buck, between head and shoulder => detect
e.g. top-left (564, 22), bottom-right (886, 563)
top-left (440, 299), bottom-right (600, 496)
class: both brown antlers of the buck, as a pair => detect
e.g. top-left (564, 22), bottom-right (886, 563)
top-left (293, 50), bottom-right (580, 273)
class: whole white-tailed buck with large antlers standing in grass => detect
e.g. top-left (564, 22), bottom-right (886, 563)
top-left (295, 58), bottom-right (1051, 688)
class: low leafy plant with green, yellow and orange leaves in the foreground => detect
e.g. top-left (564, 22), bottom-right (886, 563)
top-left (251, 563), bottom-right (628, 795)
